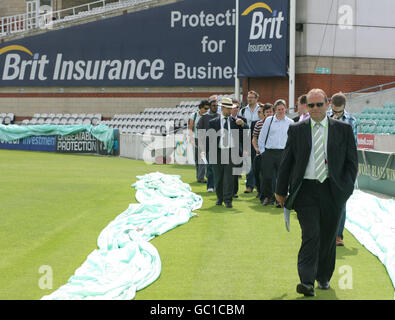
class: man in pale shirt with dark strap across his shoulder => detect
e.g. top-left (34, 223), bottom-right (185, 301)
top-left (258, 99), bottom-right (294, 206)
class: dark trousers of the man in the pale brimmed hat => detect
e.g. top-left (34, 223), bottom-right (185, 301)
top-left (212, 151), bottom-right (234, 203)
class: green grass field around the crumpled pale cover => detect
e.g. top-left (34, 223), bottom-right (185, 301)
top-left (0, 150), bottom-right (394, 300)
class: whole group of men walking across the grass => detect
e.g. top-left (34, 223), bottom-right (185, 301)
top-left (189, 89), bottom-right (358, 296)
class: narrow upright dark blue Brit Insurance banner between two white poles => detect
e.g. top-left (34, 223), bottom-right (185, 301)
top-left (237, 0), bottom-right (289, 78)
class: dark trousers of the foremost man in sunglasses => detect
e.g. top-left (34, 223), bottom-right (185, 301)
top-left (294, 179), bottom-right (342, 285)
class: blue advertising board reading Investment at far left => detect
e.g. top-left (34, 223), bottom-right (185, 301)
top-left (0, 136), bottom-right (56, 152)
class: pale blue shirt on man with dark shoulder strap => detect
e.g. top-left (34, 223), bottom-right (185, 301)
top-left (258, 116), bottom-right (295, 153)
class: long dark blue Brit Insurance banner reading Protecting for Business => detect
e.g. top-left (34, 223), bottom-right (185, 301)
top-left (0, 0), bottom-right (236, 86)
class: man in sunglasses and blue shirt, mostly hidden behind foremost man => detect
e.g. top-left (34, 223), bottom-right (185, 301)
top-left (328, 92), bottom-right (358, 246)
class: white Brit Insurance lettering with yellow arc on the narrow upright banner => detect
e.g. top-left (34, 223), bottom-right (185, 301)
top-left (241, 2), bottom-right (286, 52)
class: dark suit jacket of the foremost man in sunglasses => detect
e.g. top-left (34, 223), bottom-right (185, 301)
top-left (276, 118), bottom-right (358, 209)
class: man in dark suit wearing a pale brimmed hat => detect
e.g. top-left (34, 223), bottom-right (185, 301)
top-left (203, 98), bottom-right (248, 208)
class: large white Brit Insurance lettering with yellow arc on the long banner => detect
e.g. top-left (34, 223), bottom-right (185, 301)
top-left (0, 45), bottom-right (165, 81)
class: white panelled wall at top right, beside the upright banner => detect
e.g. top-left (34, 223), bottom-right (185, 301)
top-left (296, 0), bottom-right (395, 59)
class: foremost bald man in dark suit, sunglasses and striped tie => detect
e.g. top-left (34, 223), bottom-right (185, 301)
top-left (276, 89), bottom-right (358, 296)
